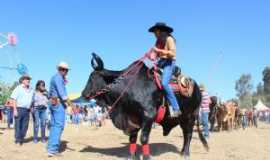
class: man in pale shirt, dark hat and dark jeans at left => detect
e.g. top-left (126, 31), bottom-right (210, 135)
top-left (10, 74), bottom-right (34, 145)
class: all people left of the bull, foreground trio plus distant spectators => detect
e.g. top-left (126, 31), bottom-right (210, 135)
top-left (0, 62), bottom-right (106, 157)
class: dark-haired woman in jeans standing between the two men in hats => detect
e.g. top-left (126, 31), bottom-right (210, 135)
top-left (32, 80), bottom-right (49, 143)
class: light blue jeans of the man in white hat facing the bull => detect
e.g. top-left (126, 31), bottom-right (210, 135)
top-left (47, 103), bottom-right (65, 153)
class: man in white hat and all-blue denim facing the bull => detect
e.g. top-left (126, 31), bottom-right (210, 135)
top-left (47, 62), bottom-right (69, 157)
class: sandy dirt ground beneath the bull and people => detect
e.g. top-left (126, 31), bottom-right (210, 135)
top-left (0, 121), bottom-right (270, 160)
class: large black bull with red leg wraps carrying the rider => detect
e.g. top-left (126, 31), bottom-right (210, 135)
top-left (82, 54), bottom-right (208, 160)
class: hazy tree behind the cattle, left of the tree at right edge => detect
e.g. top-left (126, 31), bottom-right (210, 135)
top-left (235, 74), bottom-right (253, 107)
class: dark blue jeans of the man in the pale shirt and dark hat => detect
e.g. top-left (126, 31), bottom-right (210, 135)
top-left (15, 107), bottom-right (29, 142)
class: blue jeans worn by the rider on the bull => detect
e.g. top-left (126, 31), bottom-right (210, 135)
top-left (158, 59), bottom-right (179, 111)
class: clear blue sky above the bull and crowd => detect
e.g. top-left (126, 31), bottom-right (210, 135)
top-left (0, 0), bottom-right (270, 99)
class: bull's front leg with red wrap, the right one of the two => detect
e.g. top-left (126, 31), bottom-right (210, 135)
top-left (141, 112), bottom-right (155, 160)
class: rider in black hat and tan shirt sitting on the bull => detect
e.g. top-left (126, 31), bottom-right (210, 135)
top-left (148, 22), bottom-right (181, 117)
